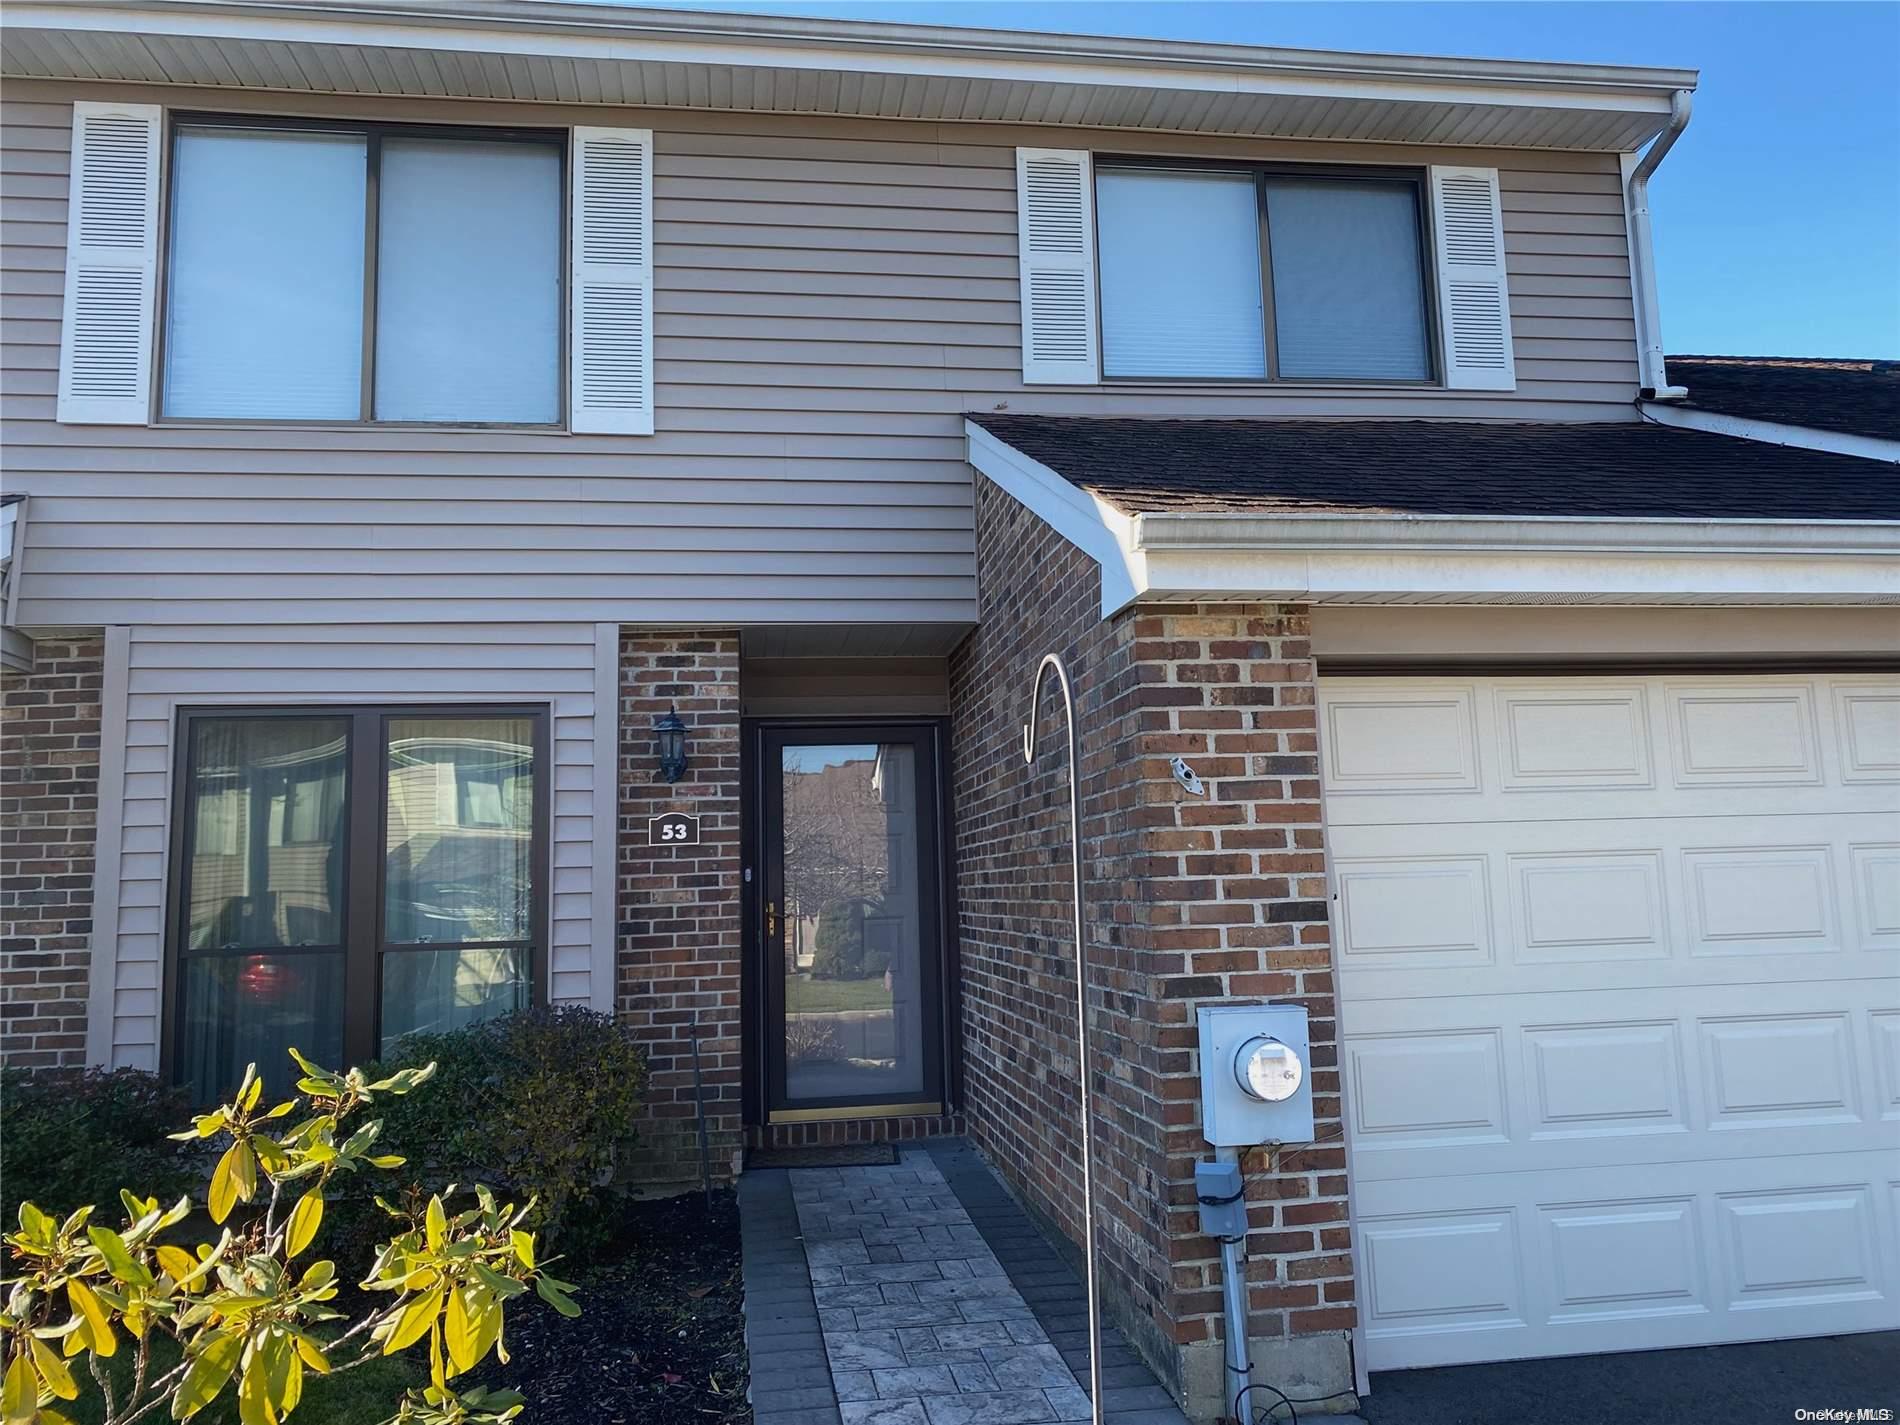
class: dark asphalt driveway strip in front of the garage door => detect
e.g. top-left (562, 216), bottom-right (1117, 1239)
top-left (1360, 1332), bottom-right (1900, 1425)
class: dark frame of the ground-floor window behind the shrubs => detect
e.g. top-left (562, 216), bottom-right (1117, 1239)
top-left (160, 703), bottom-right (553, 1087)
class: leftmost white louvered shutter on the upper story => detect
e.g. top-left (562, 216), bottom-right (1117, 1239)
top-left (59, 103), bottom-right (162, 426)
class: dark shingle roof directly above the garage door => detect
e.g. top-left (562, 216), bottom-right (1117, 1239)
top-left (971, 412), bottom-right (1900, 521)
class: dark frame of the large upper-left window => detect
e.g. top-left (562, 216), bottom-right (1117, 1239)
top-left (150, 110), bottom-right (574, 431)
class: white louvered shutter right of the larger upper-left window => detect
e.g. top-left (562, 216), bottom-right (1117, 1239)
top-left (568, 127), bottom-right (654, 435)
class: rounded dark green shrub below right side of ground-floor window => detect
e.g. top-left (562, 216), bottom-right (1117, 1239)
top-left (359, 1005), bottom-right (646, 1250)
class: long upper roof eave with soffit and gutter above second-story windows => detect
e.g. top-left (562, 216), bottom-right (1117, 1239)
top-left (0, 0), bottom-right (1697, 152)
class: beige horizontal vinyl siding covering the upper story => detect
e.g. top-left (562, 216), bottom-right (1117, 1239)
top-left (0, 82), bottom-right (1638, 627)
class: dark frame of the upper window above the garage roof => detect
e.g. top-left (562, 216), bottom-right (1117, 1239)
top-left (1089, 154), bottom-right (1444, 391)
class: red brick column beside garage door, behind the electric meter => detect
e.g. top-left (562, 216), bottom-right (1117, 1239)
top-left (1134, 604), bottom-right (1355, 1414)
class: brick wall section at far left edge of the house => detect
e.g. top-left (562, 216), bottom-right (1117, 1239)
top-left (0, 637), bottom-right (105, 1068)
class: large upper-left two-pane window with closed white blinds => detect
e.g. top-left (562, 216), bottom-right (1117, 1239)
top-left (160, 120), bottom-right (566, 426)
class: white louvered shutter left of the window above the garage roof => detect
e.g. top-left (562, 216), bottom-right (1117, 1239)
top-left (1017, 148), bottom-right (1100, 386)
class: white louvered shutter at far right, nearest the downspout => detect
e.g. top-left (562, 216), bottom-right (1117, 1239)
top-left (1431, 167), bottom-right (1518, 391)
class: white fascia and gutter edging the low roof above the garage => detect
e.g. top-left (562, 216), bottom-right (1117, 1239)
top-left (965, 412), bottom-right (1900, 618)
